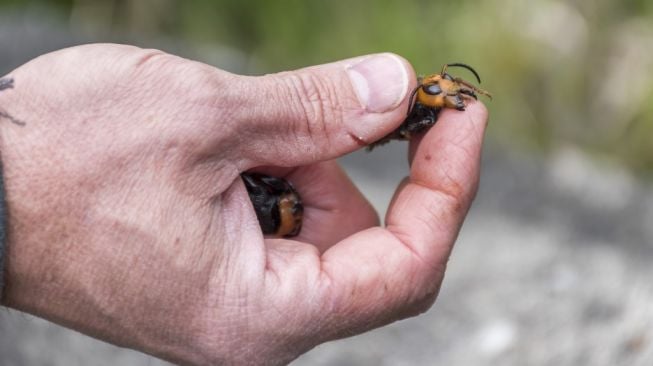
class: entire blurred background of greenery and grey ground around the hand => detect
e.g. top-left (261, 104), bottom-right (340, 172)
top-left (0, 0), bottom-right (653, 366)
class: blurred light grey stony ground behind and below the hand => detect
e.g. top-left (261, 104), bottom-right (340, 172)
top-left (0, 10), bottom-right (653, 366)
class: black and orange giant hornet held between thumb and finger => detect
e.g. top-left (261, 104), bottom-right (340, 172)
top-left (240, 63), bottom-right (492, 237)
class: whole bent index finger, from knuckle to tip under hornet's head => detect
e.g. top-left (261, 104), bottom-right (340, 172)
top-left (322, 102), bottom-right (487, 330)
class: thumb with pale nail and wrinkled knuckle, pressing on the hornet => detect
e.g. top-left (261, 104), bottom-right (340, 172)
top-left (235, 53), bottom-right (415, 166)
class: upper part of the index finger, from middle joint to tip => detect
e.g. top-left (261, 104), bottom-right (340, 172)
top-left (386, 102), bottom-right (487, 264)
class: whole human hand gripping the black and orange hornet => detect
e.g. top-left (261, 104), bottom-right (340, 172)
top-left (0, 45), bottom-right (487, 364)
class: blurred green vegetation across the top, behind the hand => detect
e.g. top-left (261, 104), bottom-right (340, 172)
top-left (0, 0), bottom-right (653, 173)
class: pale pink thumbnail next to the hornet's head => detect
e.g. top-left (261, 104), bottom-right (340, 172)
top-left (347, 53), bottom-right (408, 113)
